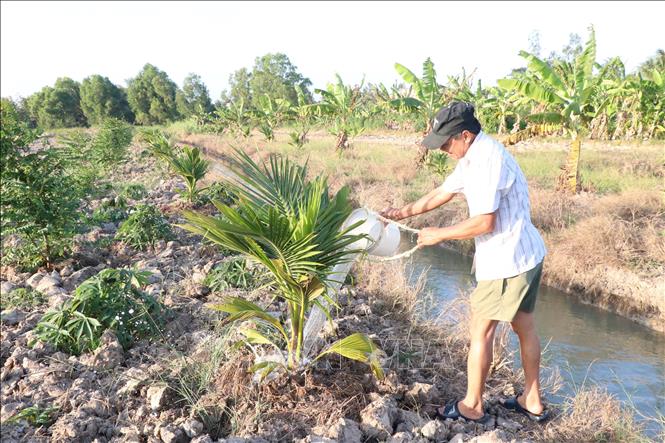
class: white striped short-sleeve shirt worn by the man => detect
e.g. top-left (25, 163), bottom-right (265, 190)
top-left (441, 131), bottom-right (547, 281)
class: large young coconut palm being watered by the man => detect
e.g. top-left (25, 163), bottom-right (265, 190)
top-left (183, 150), bottom-right (383, 377)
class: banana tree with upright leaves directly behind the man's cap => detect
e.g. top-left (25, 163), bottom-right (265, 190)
top-left (395, 57), bottom-right (446, 165)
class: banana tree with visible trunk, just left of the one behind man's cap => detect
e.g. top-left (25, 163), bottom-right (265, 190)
top-left (314, 74), bottom-right (365, 152)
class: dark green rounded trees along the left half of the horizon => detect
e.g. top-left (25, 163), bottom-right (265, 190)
top-left (2, 53), bottom-right (312, 129)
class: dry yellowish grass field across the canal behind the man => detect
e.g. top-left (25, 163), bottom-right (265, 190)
top-left (172, 127), bottom-right (665, 332)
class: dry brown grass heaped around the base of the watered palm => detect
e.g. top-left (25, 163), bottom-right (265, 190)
top-left (201, 353), bottom-right (374, 441)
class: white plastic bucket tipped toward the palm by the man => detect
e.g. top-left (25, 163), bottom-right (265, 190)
top-left (343, 208), bottom-right (401, 257)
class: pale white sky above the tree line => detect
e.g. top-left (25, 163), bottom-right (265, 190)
top-left (0, 1), bottom-right (665, 100)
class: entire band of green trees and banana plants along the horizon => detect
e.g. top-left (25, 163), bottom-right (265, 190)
top-left (3, 38), bottom-right (665, 147)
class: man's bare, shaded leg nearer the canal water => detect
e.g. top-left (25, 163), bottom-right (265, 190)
top-left (511, 311), bottom-right (543, 414)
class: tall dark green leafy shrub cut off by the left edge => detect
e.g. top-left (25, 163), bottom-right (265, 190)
top-left (0, 107), bottom-right (81, 271)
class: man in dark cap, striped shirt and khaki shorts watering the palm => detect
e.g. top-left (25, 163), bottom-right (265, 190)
top-left (381, 102), bottom-right (548, 423)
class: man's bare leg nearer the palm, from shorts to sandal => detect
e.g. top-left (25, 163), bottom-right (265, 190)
top-left (458, 317), bottom-right (499, 419)
